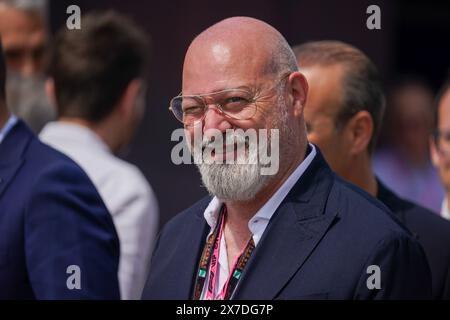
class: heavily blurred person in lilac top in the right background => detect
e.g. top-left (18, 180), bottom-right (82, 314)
top-left (374, 77), bottom-right (444, 212)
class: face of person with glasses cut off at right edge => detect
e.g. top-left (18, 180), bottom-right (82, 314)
top-left (431, 79), bottom-right (450, 220)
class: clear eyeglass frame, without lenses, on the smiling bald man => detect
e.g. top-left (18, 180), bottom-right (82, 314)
top-left (169, 71), bottom-right (295, 128)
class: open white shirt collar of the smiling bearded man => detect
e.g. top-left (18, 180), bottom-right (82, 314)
top-left (204, 144), bottom-right (317, 242)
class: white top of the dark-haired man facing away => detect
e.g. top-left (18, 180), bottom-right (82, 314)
top-left (39, 122), bottom-right (159, 299)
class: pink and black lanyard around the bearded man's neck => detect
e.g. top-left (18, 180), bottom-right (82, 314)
top-left (193, 205), bottom-right (255, 300)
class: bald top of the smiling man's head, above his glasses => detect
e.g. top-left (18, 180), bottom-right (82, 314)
top-left (183, 17), bottom-right (298, 94)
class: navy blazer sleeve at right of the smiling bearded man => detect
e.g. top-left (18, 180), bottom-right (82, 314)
top-left (354, 233), bottom-right (432, 300)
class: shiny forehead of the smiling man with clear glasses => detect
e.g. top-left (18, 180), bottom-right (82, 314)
top-left (182, 41), bottom-right (267, 94)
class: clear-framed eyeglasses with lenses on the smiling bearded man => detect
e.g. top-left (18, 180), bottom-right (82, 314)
top-left (169, 73), bottom-right (290, 127)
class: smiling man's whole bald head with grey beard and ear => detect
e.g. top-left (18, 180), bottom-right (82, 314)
top-left (178, 17), bottom-right (308, 201)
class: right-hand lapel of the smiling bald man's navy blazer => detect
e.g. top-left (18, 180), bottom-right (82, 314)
top-left (232, 152), bottom-right (337, 299)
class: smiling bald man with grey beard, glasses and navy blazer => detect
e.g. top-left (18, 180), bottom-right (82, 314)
top-left (143, 17), bottom-right (431, 300)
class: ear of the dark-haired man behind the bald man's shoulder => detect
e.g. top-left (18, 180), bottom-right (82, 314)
top-left (347, 110), bottom-right (374, 155)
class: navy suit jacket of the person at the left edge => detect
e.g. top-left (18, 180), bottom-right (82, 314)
top-left (0, 121), bottom-right (119, 299)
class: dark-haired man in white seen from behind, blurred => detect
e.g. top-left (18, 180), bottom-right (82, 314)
top-left (40, 11), bottom-right (158, 299)
